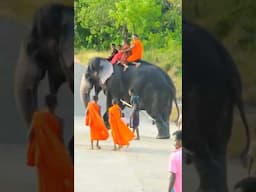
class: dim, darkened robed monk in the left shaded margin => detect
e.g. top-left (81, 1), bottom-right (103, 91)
top-left (27, 95), bottom-right (74, 192)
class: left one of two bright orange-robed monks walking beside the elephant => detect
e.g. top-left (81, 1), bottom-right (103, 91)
top-left (85, 96), bottom-right (109, 149)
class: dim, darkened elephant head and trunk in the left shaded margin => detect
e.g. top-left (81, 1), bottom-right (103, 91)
top-left (14, 4), bottom-right (74, 160)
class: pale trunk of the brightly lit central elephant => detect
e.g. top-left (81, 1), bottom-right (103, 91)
top-left (80, 72), bottom-right (92, 108)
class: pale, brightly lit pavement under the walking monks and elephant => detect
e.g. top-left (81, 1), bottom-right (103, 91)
top-left (74, 117), bottom-right (178, 192)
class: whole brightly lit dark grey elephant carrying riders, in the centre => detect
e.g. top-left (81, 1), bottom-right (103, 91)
top-left (80, 57), bottom-right (179, 139)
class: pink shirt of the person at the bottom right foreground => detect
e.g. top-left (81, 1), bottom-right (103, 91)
top-left (168, 148), bottom-right (182, 192)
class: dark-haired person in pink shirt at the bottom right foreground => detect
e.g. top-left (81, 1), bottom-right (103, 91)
top-left (168, 130), bottom-right (182, 192)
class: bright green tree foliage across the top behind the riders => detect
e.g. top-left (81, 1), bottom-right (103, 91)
top-left (75, 0), bottom-right (181, 50)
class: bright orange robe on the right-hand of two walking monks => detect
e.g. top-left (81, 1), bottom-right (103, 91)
top-left (108, 104), bottom-right (135, 146)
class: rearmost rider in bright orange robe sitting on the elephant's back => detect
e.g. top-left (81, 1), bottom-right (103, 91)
top-left (121, 34), bottom-right (144, 67)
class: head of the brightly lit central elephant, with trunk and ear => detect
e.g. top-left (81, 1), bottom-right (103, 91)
top-left (80, 57), bottom-right (114, 107)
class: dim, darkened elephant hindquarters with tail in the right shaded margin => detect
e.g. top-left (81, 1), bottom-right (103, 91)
top-left (182, 19), bottom-right (250, 192)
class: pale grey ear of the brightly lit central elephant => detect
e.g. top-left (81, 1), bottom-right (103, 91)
top-left (99, 59), bottom-right (114, 84)
